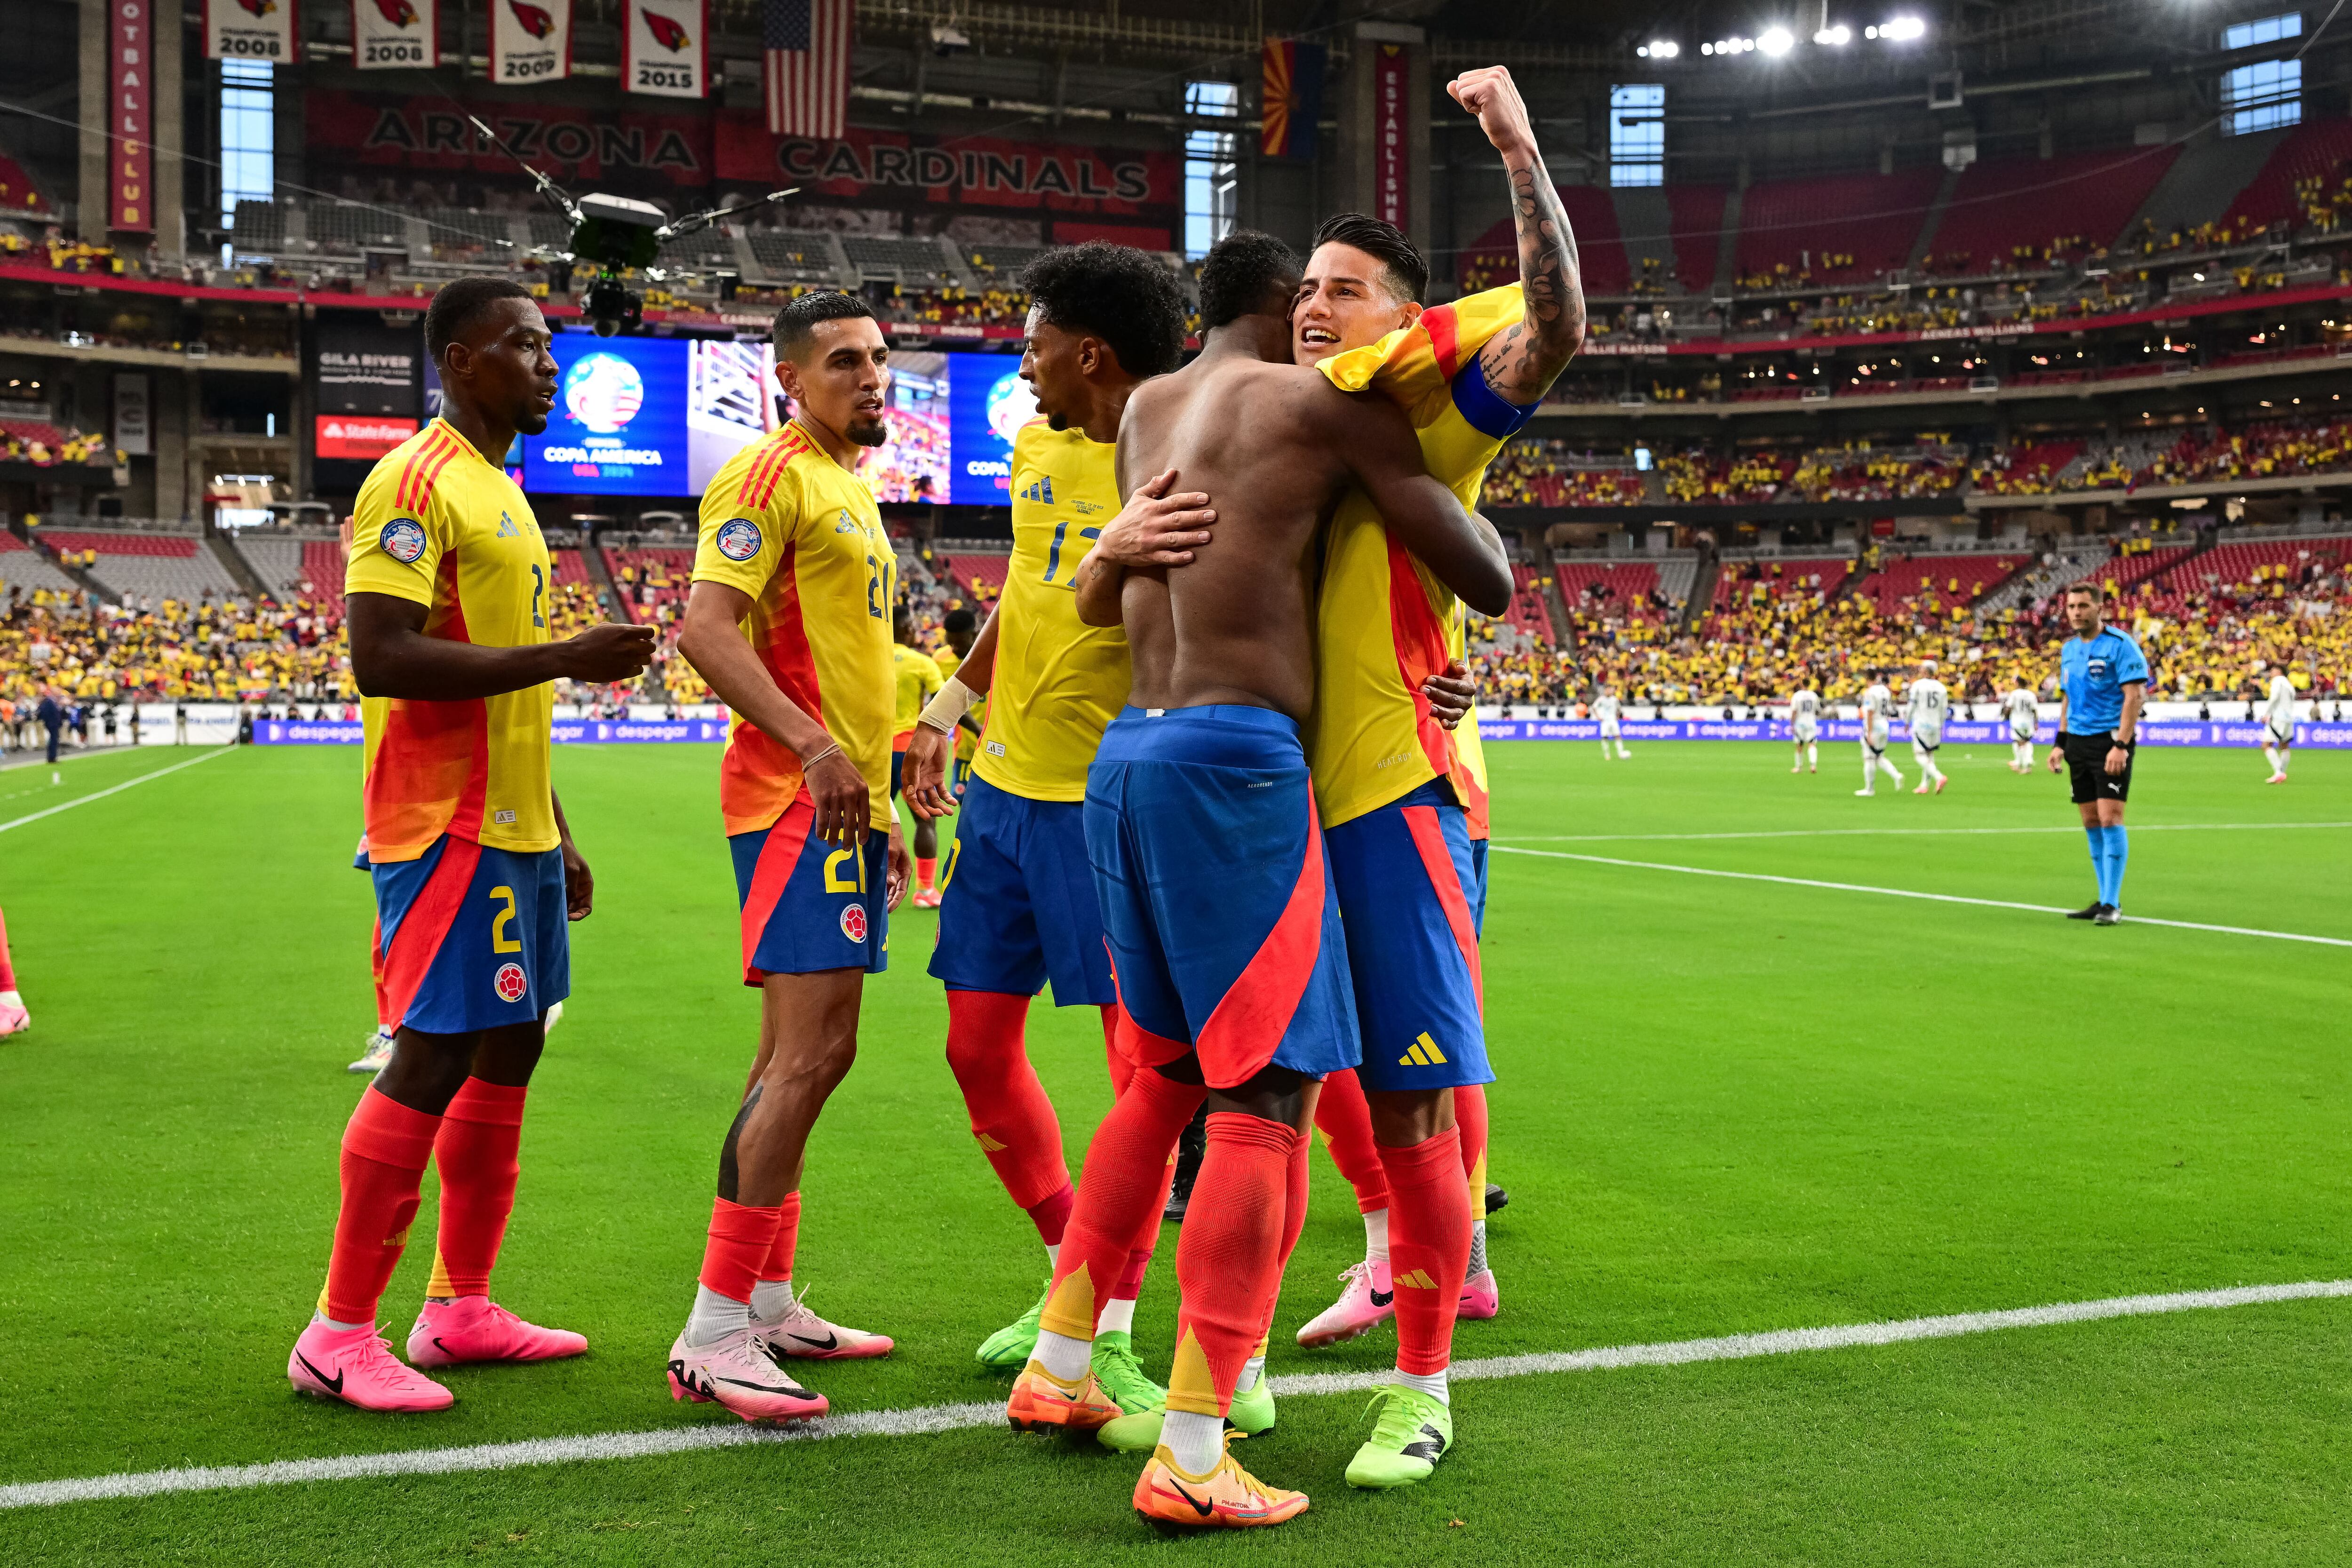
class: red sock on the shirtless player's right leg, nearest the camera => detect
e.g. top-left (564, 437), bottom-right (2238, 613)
top-left (1167, 1112), bottom-right (1301, 1417)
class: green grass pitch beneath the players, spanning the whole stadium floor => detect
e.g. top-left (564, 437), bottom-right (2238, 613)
top-left (0, 743), bottom-right (2352, 1568)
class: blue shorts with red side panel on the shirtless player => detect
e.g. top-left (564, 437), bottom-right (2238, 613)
top-left (1084, 705), bottom-right (1357, 1089)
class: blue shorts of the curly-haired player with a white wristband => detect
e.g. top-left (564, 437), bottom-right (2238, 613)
top-left (931, 778), bottom-right (1117, 1006)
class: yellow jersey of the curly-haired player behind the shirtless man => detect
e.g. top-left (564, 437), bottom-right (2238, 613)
top-left (974, 418), bottom-right (1134, 799)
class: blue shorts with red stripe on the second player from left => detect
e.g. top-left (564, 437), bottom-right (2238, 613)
top-left (727, 790), bottom-right (889, 985)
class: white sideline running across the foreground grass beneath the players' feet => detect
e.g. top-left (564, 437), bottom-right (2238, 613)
top-left (0, 1279), bottom-right (2352, 1509)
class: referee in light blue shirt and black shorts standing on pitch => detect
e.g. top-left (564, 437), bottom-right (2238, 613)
top-left (2051, 583), bottom-right (2147, 926)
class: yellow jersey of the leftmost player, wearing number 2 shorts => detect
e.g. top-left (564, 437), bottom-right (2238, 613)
top-left (343, 418), bottom-right (562, 863)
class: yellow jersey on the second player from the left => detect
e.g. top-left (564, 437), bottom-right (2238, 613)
top-left (694, 421), bottom-right (898, 837)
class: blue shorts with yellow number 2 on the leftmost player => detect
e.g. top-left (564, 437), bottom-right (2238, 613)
top-left (369, 835), bottom-right (572, 1035)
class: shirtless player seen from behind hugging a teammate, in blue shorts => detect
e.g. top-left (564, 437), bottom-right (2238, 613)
top-left (1004, 233), bottom-right (1512, 1528)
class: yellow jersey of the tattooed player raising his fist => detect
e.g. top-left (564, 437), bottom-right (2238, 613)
top-left (1308, 285), bottom-right (1524, 837)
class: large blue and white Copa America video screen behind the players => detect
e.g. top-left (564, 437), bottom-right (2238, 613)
top-left (501, 332), bottom-right (1037, 505)
